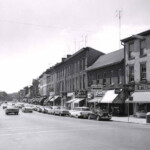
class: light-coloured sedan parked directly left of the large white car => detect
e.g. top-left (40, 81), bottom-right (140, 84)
top-left (54, 107), bottom-right (69, 116)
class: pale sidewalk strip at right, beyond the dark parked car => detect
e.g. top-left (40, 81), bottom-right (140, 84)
top-left (111, 116), bottom-right (150, 125)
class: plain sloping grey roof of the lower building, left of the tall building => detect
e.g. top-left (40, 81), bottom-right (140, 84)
top-left (86, 49), bottom-right (124, 71)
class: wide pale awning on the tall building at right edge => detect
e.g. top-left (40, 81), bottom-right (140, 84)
top-left (126, 92), bottom-right (150, 103)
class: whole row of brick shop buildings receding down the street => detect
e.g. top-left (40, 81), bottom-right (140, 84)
top-left (19, 30), bottom-right (150, 116)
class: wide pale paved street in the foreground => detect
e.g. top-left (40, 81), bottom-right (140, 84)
top-left (0, 107), bottom-right (150, 150)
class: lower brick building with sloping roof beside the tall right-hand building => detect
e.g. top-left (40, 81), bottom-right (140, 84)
top-left (87, 49), bottom-right (125, 115)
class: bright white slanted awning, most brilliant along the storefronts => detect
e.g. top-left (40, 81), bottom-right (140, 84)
top-left (100, 90), bottom-right (118, 103)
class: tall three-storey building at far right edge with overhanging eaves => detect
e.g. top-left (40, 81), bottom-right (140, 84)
top-left (121, 30), bottom-right (150, 117)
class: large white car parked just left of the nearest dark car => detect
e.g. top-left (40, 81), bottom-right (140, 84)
top-left (69, 107), bottom-right (92, 118)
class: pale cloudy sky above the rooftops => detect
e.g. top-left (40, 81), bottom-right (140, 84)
top-left (0, 0), bottom-right (150, 93)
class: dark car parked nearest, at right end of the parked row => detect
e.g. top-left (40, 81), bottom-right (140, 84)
top-left (88, 109), bottom-right (112, 121)
